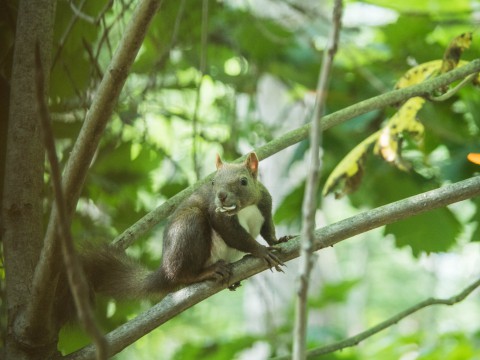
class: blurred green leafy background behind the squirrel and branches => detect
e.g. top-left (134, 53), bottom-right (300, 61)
top-left (0, 0), bottom-right (480, 360)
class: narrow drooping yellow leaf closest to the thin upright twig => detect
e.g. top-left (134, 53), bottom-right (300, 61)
top-left (323, 131), bottom-right (380, 199)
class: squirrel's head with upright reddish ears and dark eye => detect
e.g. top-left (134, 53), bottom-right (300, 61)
top-left (212, 152), bottom-right (258, 216)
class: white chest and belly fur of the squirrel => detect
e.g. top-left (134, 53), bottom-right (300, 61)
top-left (208, 205), bottom-right (265, 264)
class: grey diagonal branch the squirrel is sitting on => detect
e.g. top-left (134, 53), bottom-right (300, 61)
top-left (66, 176), bottom-right (480, 360)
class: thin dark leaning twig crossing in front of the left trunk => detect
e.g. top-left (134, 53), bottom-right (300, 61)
top-left (35, 43), bottom-right (107, 360)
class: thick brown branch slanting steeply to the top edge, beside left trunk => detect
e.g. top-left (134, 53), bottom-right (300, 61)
top-left (30, 0), bottom-right (161, 338)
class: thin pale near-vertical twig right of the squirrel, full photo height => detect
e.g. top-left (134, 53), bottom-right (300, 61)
top-left (293, 0), bottom-right (343, 360)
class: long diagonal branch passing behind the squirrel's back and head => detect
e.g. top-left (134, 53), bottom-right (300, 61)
top-left (114, 59), bottom-right (480, 249)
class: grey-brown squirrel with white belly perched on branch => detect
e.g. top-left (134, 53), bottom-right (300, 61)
top-left (58, 152), bottom-right (287, 322)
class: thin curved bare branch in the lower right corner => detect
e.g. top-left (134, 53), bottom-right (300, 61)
top-left (272, 279), bottom-right (480, 360)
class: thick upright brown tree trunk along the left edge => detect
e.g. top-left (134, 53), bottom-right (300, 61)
top-left (2, 0), bottom-right (56, 360)
